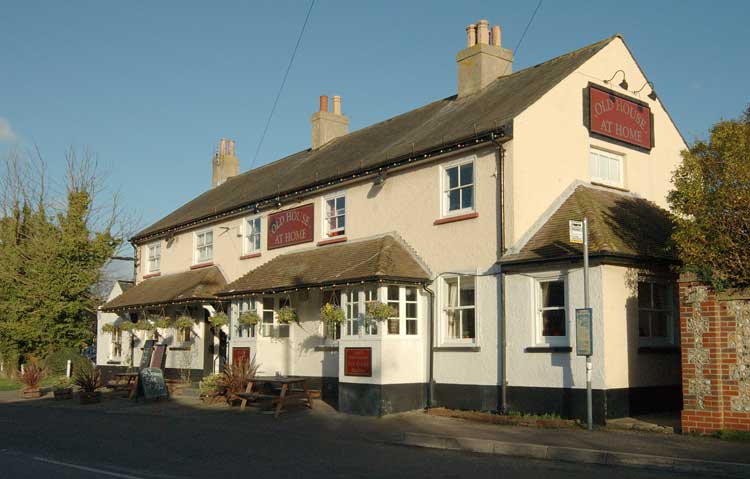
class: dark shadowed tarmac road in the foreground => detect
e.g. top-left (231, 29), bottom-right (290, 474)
top-left (0, 403), bottom-right (716, 479)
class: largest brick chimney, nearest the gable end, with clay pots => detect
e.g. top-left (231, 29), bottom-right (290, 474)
top-left (456, 20), bottom-right (513, 98)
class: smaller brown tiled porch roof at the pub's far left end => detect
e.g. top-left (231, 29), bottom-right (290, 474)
top-left (101, 266), bottom-right (227, 311)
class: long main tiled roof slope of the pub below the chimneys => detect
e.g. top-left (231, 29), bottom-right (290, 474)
top-left (133, 36), bottom-right (615, 241)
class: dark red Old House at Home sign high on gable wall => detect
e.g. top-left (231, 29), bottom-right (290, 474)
top-left (588, 85), bottom-right (653, 150)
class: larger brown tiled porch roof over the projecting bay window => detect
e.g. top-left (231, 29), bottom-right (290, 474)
top-left (217, 233), bottom-right (430, 296)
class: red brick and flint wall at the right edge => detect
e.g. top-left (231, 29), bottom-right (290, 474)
top-left (680, 275), bottom-right (750, 433)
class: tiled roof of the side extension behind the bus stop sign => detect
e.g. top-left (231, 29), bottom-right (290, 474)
top-left (501, 185), bottom-right (675, 263)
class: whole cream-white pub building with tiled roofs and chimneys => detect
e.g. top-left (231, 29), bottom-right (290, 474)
top-left (98, 20), bottom-right (686, 422)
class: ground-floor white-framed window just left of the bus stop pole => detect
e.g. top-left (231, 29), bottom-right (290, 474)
top-left (536, 277), bottom-right (569, 346)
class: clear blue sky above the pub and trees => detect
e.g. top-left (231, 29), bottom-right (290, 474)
top-left (0, 0), bottom-right (750, 238)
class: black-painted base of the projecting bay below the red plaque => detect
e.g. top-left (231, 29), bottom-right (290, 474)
top-left (338, 382), bottom-right (427, 416)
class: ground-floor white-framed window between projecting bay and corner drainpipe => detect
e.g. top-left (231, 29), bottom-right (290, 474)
top-left (442, 275), bottom-right (477, 342)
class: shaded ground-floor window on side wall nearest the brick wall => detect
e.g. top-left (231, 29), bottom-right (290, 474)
top-left (638, 278), bottom-right (675, 345)
